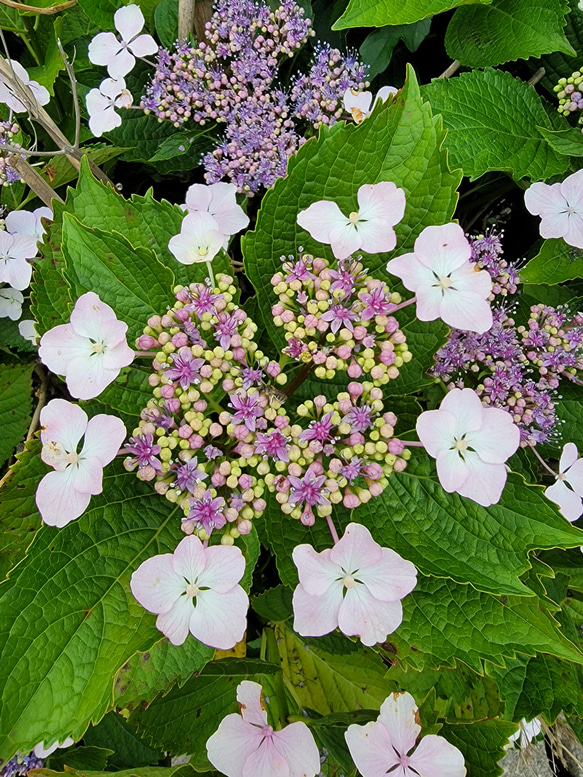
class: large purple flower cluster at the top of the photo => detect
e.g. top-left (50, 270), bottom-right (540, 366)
top-left (141, 0), bottom-right (366, 196)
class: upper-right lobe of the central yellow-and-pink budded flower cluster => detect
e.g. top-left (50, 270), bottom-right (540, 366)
top-left (271, 251), bottom-right (411, 386)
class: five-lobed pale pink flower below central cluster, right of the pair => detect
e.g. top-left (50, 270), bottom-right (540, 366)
top-left (292, 523), bottom-right (417, 645)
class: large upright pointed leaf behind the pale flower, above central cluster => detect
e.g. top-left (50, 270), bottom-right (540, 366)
top-left (242, 68), bottom-right (460, 345)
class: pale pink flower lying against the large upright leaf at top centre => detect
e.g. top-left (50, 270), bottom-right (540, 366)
top-left (297, 181), bottom-right (405, 259)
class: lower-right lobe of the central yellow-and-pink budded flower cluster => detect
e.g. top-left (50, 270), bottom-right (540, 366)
top-left (266, 382), bottom-right (410, 526)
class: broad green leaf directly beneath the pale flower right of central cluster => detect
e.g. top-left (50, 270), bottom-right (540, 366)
top-left (354, 455), bottom-right (583, 596)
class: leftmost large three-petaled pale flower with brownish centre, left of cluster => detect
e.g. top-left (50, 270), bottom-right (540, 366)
top-left (36, 399), bottom-right (126, 527)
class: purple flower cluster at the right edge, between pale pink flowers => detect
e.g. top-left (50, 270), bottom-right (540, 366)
top-left (432, 305), bottom-right (583, 446)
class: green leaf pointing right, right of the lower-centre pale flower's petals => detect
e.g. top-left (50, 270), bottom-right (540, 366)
top-left (383, 577), bottom-right (583, 673)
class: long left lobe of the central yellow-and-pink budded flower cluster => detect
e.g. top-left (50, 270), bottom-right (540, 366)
top-left (125, 275), bottom-right (289, 544)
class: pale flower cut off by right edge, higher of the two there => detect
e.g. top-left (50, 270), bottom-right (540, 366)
top-left (524, 170), bottom-right (583, 248)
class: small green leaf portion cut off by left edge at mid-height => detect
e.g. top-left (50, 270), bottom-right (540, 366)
top-left (0, 364), bottom-right (34, 465)
